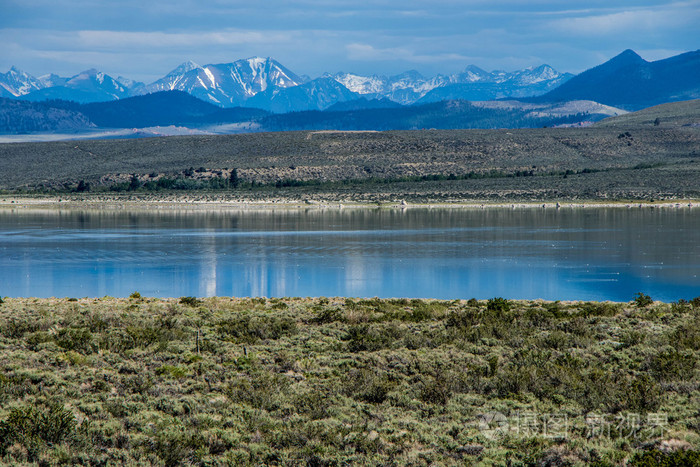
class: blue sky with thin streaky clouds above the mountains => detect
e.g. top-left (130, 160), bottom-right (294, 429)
top-left (0, 0), bottom-right (700, 83)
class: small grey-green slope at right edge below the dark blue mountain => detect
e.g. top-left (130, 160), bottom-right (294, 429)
top-left (596, 99), bottom-right (700, 128)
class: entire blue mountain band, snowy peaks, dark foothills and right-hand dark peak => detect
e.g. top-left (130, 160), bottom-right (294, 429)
top-left (0, 50), bottom-right (700, 139)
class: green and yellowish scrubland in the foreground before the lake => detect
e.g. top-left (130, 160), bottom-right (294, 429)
top-left (0, 293), bottom-right (700, 465)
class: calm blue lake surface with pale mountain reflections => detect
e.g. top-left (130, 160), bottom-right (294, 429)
top-left (0, 207), bottom-right (700, 301)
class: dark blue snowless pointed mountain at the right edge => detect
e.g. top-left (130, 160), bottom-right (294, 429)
top-left (532, 50), bottom-right (700, 110)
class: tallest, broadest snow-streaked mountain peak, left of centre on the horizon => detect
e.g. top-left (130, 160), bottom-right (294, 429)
top-left (145, 57), bottom-right (304, 107)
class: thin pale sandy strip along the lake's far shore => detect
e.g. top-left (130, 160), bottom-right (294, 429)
top-left (0, 194), bottom-right (700, 210)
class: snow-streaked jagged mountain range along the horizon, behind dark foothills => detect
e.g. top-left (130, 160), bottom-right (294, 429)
top-left (0, 57), bottom-right (573, 113)
